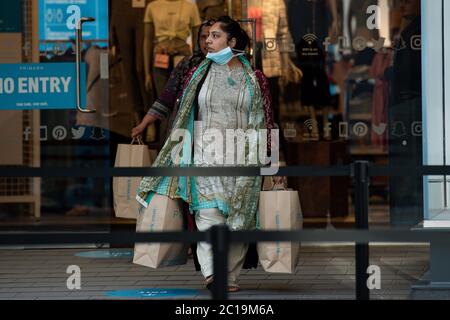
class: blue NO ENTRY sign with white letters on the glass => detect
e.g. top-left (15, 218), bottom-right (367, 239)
top-left (0, 63), bottom-right (86, 110)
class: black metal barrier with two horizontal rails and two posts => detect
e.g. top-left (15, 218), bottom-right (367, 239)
top-left (0, 161), bottom-right (450, 300)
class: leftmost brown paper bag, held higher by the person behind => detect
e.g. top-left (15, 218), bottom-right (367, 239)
top-left (113, 139), bottom-right (153, 219)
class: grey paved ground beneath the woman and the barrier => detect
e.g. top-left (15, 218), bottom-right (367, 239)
top-left (0, 244), bottom-right (429, 300)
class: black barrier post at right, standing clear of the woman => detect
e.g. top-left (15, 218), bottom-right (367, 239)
top-left (353, 161), bottom-right (370, 300)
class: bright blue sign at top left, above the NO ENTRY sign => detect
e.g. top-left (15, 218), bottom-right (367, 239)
top-left (39, 0), bottom-right (108, 41)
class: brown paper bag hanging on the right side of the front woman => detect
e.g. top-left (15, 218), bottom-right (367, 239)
top-left (258, 191), bottom-right (303, 273)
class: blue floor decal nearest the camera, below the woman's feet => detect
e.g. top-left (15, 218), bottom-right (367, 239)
top-left (106, 288), bottom-right (200, 298)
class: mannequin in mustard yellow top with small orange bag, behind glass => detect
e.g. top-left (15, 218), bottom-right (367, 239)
top-left (144, 0), bottom-right (201, 96)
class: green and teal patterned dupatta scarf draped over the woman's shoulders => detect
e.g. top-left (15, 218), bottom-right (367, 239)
top-left (136, 56), bottom-right (266, 230)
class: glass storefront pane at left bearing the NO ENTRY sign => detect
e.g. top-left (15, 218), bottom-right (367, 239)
top-left (0, 0), bottom-right (114, 230)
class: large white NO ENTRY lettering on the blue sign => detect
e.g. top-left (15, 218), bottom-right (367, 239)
top-left (0, 77), bottom-right (72, 94)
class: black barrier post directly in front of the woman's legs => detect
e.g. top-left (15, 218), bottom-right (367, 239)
top-left (210, 225), bottom-right (230, 300)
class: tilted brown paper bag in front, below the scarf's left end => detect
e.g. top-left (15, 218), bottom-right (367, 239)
top-left (133, 194), bottom-right (188, 269)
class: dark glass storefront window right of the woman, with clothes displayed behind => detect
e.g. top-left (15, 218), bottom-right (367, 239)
top-left (236, 0), bottom-right (424, 227)
